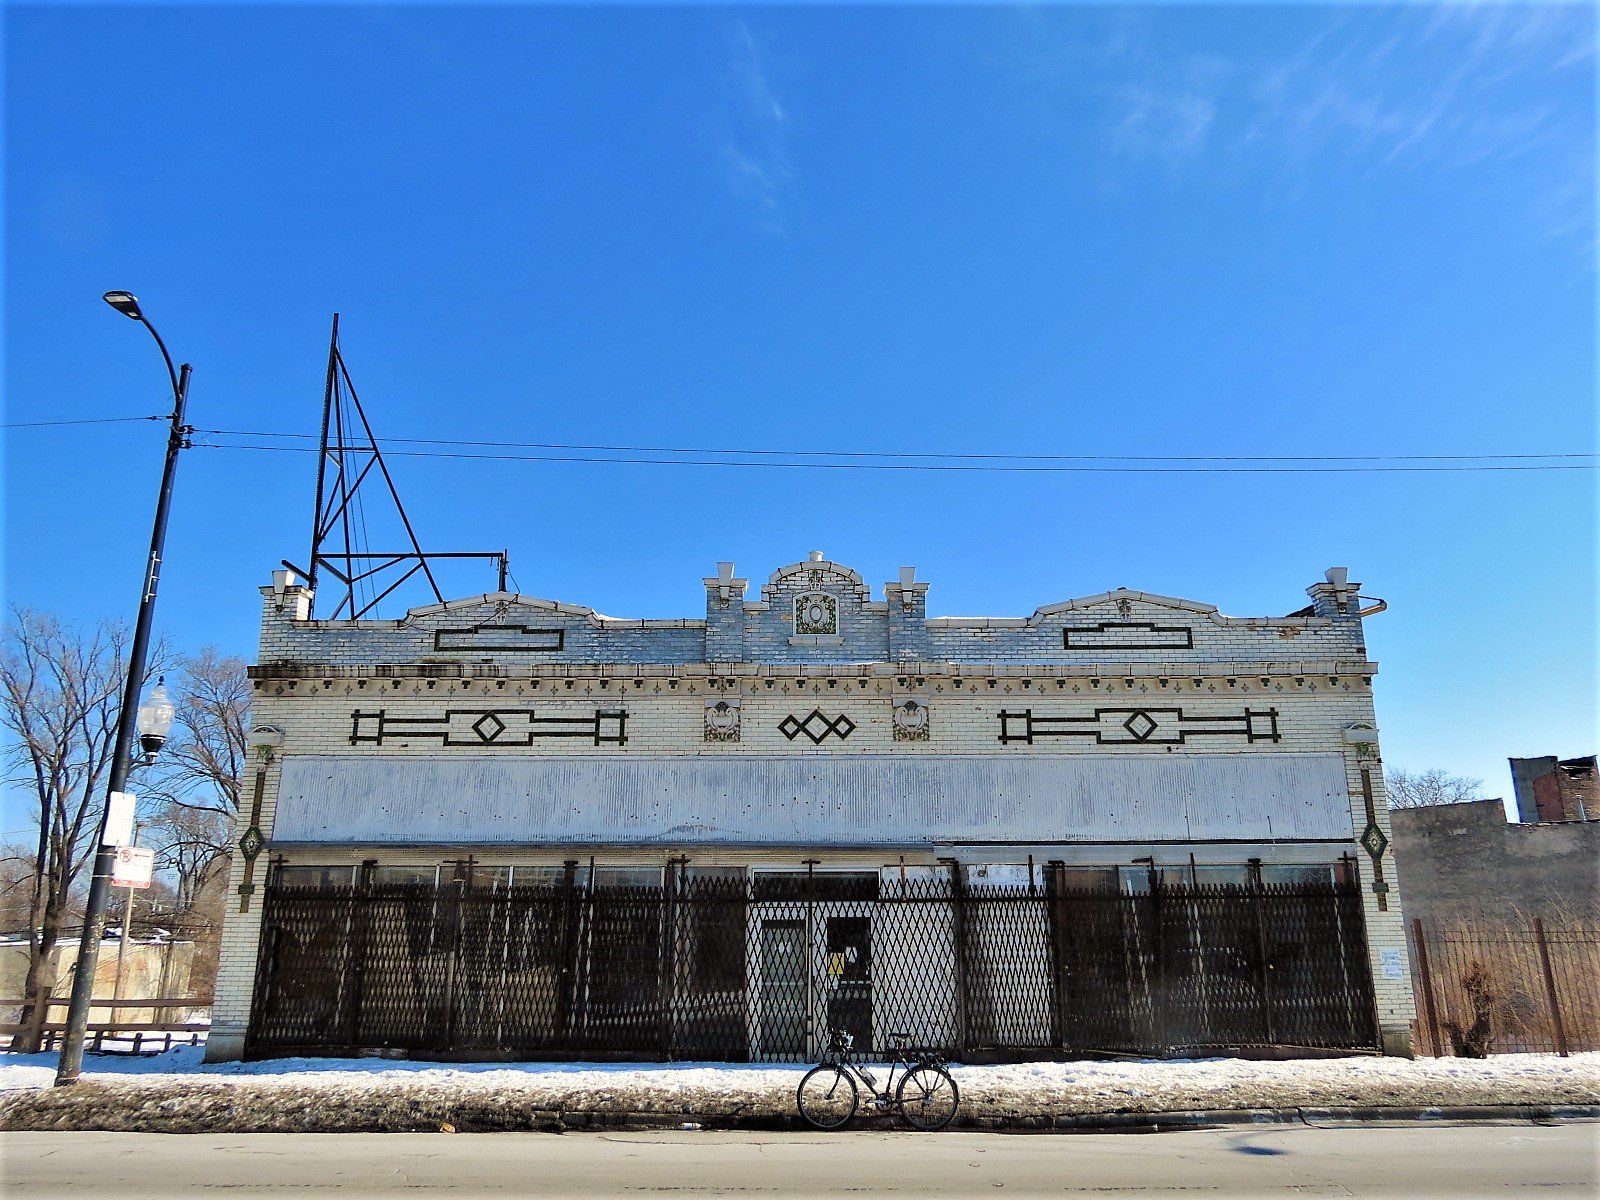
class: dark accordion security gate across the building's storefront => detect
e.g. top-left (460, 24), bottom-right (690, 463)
top-left (246, 864), bottom-right (1378, 1061)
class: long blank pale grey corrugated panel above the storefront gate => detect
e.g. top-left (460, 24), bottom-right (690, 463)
top-left (272, 754), bottom-right (1352, 846)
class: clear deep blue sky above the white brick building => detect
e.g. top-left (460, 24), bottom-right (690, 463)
top-left (3, 5), bottom-right (1597, 829)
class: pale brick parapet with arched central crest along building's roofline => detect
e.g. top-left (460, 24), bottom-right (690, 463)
top-left (259, 557), bottom-right (1365, 677)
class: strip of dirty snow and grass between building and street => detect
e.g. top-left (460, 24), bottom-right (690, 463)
top-left (0, 1046), bottom-right (1600, 1133)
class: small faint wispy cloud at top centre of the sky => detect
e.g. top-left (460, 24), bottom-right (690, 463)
top-left (720, 21), bottom-right (795, 234)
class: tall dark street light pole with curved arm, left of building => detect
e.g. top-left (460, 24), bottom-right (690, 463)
top-left (56, 291), bottom-right (194, 1088)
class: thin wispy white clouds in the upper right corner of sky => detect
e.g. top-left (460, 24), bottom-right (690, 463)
top-left (1075, 3), bottom-right (1595, 243)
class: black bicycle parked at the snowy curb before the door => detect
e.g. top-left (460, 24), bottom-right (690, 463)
top-left (795, 1029), bottom-right (962, 1133)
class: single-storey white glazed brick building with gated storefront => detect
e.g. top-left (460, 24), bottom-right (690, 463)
top-left (208, 554), bottom-right (1413, 1059)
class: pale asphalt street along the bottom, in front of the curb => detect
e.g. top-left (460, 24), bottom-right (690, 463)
top-left (0, 1123), bottom-right (1600, 1200)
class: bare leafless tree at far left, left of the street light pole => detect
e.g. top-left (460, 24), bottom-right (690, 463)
top-left (0, 608), bottom-right (166, 1053)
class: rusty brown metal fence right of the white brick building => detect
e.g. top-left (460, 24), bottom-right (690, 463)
top-left (1411, 917), bottom-right (1600, 1058)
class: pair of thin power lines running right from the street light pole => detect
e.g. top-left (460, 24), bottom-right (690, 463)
top-left (195, 442), bottom-right (1600, 475)
